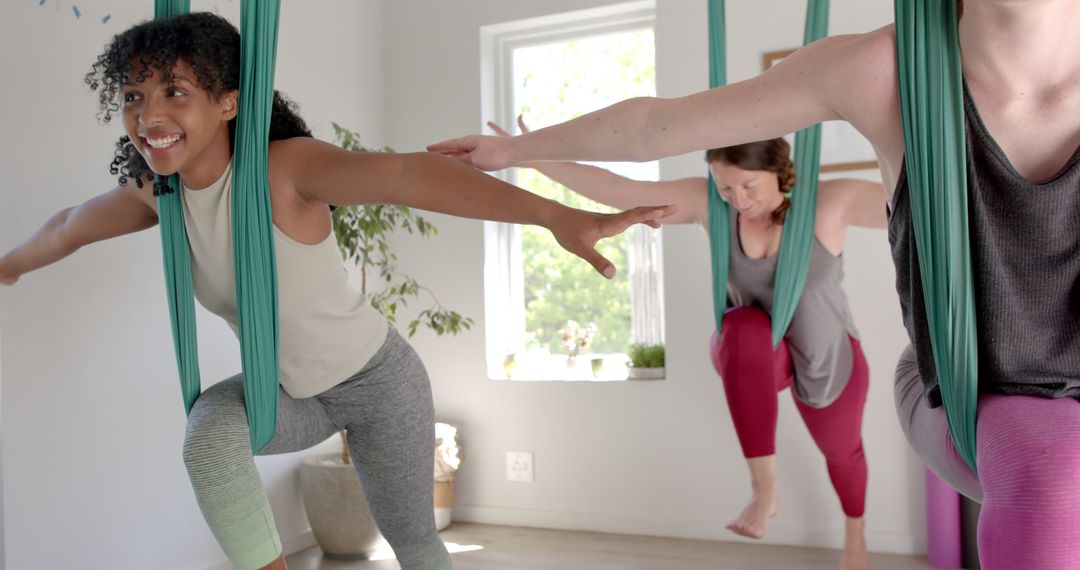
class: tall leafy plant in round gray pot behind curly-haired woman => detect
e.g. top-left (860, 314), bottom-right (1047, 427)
top-left (300, 123), bottom-right (473, 559)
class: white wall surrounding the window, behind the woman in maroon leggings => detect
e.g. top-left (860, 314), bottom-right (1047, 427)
top-left (384, 0), bottom-right (926, 553)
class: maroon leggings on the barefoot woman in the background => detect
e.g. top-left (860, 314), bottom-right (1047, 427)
top-left (710, 307), bottom-right (869, 518)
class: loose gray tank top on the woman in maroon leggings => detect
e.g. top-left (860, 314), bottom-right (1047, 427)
top-left (728, 208), bottom-right (859, 408)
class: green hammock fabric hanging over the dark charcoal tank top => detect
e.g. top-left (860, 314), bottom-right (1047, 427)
top-left (895, 0), bottom-right (978, 473)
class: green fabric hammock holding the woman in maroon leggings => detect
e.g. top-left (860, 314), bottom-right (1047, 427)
top-left (708, 0), bottom-right (828, 347)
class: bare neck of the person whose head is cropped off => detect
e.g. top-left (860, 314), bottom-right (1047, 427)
top-left (960, 0), bottom-right (1080, 91)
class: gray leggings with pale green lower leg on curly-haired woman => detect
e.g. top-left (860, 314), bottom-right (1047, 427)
top-left (184, 328), bottom-right (451, 570)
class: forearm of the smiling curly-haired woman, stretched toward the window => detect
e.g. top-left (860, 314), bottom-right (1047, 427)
top-left (395, 153), bottom-right (569, 228)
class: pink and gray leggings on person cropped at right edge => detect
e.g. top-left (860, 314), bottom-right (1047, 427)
top-left (895, 347), bottom-right (1080, 570)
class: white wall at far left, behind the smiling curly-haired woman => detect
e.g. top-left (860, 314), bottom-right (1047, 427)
top-left (0, 0), bottom-right (382, 570)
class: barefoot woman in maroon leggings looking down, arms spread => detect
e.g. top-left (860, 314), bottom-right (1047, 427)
top-left (489, 120), bottom-right (886, 568)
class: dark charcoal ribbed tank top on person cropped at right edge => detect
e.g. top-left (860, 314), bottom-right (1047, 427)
top-left (889, 85), bottom-right (1080, 407)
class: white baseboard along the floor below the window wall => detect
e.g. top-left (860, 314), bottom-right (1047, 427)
top-left (454, 505), bottom-right (926, 555)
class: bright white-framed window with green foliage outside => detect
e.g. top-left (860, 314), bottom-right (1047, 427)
top-left (482, 2), bottom-right (663, 380)
